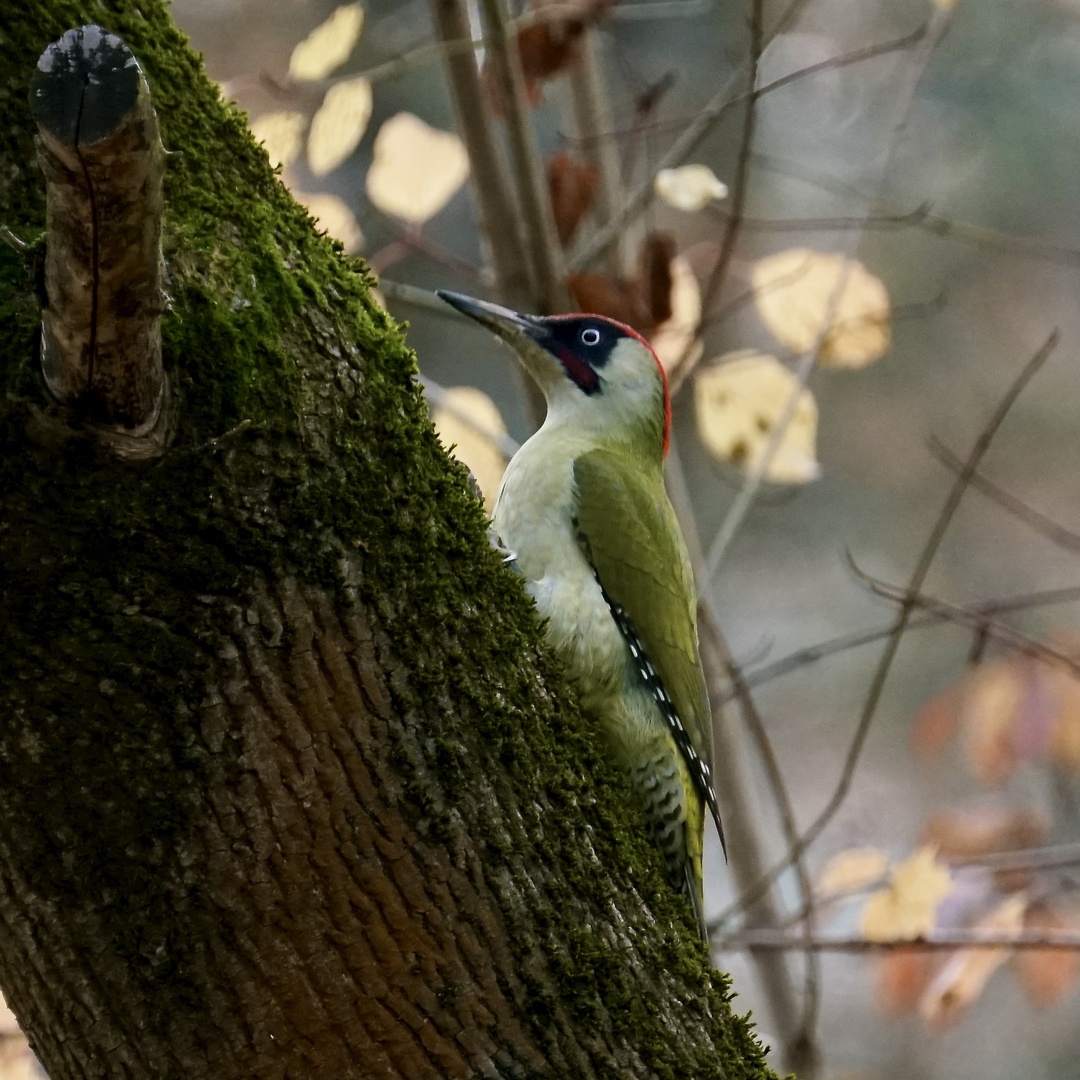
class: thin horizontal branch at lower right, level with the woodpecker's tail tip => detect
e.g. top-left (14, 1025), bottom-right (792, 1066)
top-left (713, 930), bottom-right (1080, 953)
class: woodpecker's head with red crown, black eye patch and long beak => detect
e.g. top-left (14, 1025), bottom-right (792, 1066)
top-left (438, 289), bottom-right (671, 454)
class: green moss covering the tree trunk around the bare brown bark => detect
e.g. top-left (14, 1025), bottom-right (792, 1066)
top-left (0, 0), bottom-right (767, 1078)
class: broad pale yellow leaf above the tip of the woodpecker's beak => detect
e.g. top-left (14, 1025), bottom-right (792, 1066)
top-left (367, 112), bottom-right (469, 225)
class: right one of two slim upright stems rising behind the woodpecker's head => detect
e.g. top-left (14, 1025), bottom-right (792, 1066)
top-left (481, 0), bottom-right (569, 314)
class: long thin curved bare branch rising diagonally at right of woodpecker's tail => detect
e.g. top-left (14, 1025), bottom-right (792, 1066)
top-left (719, 330), bottom-right (1057, 924)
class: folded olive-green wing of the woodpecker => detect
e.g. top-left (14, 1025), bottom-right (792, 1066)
top-left (573, 449), bottom-right (713, 777)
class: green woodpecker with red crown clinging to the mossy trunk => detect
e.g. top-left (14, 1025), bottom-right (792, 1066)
top-left (438, 292), bottom-right (724, 936)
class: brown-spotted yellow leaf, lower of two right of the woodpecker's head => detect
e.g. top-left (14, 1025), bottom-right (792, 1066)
top-left (694, 350), bottom-right (821, 484)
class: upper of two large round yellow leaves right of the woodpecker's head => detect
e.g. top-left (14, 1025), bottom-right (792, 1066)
top-left (752, 247), bottom-right (891, 367)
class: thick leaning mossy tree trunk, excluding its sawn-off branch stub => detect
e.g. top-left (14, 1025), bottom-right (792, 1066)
top-left (0, 0), bottom-right (768, 1080)
